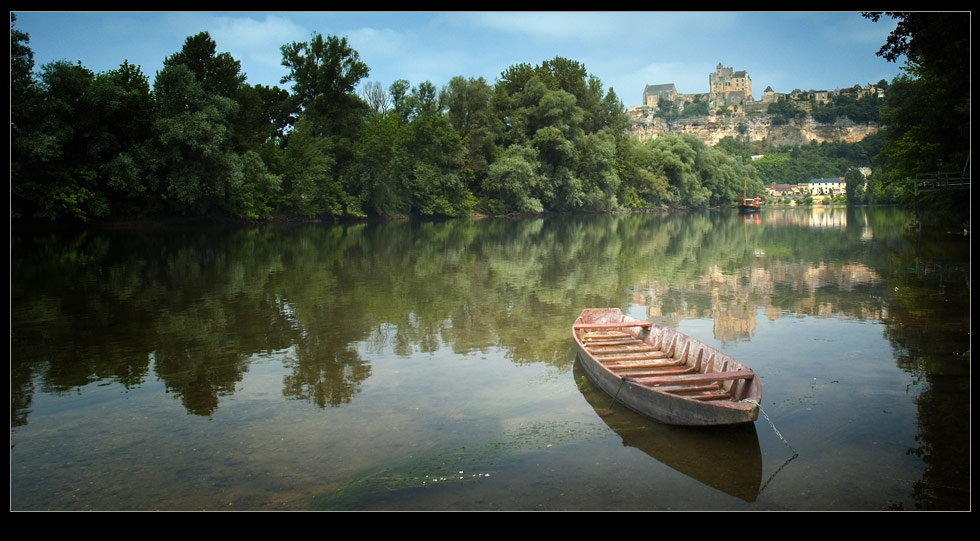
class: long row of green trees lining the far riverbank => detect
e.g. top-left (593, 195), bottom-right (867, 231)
top-left (11, 14), bottom-right (968, 222)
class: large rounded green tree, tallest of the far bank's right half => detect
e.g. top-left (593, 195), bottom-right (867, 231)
top-left (483, 57), bottom-right (628, 212)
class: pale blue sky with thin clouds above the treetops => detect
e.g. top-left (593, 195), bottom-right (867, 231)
top-left (14, 11), bottom-right (902, 107)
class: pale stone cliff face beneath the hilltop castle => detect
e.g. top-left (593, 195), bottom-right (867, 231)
top-left (631, 115), bottom-right (878, 146)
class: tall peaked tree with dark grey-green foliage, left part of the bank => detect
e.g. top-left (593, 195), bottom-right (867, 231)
top-left (153, 32), bottom-right (292, 218)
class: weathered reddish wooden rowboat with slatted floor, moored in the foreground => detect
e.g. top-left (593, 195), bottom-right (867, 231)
top-left (572, 308), bottom-right (762, 426)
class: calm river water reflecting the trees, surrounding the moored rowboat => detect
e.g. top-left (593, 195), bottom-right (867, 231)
top-left (10, 208), bottom-right (971, 510)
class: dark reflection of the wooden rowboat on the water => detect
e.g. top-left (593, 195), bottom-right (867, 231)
top-left (573, 359), bottom-right (762, 502)
